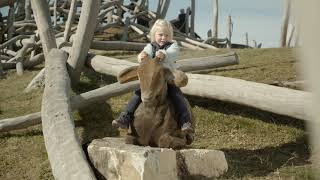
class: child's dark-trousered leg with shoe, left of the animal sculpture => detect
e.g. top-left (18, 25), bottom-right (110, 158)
top-left (112, 89), bottom-right (142, 129)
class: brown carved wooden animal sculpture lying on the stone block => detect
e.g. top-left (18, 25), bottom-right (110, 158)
top-left (118, 58), bottom-right (194, 149)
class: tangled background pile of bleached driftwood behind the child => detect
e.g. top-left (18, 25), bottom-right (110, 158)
top-left (0, 0), bottom-right (225, 75)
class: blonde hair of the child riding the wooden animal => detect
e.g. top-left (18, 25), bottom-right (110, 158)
top-left (150, 19), bottom-right (173, 42)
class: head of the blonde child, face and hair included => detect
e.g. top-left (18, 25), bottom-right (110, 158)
top-left (150, 19), bottom-right (173, 46)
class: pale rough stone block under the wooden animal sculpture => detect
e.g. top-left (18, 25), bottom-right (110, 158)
top-left (88, 137), bottom-right (228, 180)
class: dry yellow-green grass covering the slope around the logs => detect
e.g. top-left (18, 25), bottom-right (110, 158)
top-left (0, 48), bottom-right (314, 179)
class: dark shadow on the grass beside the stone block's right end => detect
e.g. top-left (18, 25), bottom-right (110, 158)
top-left (221, 136), bottom-right (311, 179)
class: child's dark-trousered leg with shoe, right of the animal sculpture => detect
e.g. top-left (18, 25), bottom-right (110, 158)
top-left (168, 84), bottom-right (193, 131)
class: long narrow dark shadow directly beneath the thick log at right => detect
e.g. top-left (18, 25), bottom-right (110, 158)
top-left (186, 96), bottom-right (306, 130)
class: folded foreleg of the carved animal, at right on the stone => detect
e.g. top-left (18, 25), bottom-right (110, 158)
top-left (158, 133), bottom-right (186, 149)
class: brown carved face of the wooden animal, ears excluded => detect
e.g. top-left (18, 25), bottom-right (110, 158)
top-left (138, 58), bottom-right (167, 102)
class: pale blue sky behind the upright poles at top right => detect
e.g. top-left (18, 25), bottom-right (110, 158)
top-left (2, 0), bottom-right (283, 48)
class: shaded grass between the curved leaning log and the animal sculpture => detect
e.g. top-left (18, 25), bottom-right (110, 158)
top-left (74, 69), bottom-right (119, 144)
